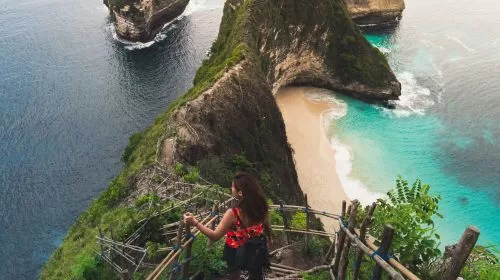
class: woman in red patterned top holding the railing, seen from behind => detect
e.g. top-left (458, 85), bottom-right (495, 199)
top-left (184, 173), bottom-right (270, 279)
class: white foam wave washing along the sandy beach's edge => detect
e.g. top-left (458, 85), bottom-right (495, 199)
top-left (330, 137), bottom-right (383, 205)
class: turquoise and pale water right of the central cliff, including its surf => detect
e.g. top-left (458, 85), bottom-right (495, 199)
top-left (332, 1), bottom-right (500, 245)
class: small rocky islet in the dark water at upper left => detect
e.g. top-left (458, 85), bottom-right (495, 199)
top-left (104, 0), bottom-right (189, 42)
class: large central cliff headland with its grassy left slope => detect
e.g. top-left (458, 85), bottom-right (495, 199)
top-left (42, 0), bottom-right (400, 279)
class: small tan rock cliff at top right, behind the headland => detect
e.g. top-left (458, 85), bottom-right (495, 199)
top-left (346, 0), bottom-right (405, 25)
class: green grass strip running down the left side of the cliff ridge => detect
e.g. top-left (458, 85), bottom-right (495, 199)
top-left (40, 1), bottom-right (254, 279)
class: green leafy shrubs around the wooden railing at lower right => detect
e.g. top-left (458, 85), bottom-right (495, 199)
top-left (349, 177), bottom-right (500, 280)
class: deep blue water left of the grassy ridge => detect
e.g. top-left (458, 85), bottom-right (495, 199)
top-left (0, 0), bottom-right (223, 280)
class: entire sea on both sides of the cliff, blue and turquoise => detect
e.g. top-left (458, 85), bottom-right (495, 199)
top-left (0, 0), bottom-right (500, 279)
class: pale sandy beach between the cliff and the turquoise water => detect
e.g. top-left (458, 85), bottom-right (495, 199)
top-left (276, 87), bottom-right (349, 231)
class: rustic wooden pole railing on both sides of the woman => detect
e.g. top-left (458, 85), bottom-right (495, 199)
top-left (97, 191), bottom-right (479, 280)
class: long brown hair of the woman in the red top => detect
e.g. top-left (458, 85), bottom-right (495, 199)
top-left (233, 172), bottom-right (269, 224)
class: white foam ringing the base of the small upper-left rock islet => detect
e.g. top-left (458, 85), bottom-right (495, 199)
top-left (109, 0), bottom-right (211, 51)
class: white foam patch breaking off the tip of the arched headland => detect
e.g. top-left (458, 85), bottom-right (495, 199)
top-left (381, 72), bottom-right (436, 118)
